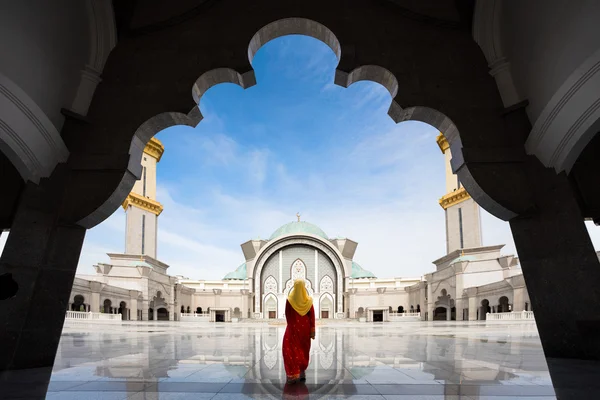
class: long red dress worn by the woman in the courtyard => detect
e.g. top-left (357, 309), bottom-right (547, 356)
top-left (282, 301), bottom-right (315, 379)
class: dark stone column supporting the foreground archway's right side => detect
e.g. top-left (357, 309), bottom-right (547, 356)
top-left (510, 165), bottom-right (600, 360)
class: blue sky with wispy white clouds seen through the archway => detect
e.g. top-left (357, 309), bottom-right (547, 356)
top-left (0, 36), bottom-right (600, 279)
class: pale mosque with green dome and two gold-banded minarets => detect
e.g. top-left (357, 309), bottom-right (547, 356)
top-left (70, 134), bottom-right (531, 322)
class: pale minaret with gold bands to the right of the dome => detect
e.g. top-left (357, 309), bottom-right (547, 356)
top-left (436, 133), bottom-right (481, 253)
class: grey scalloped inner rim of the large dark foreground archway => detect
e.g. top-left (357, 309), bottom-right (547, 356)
top-left (84, 18), bottom-right (517, 233)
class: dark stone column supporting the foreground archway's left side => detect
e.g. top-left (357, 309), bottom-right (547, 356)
top-left (0, 177), bottom-right (85, 379)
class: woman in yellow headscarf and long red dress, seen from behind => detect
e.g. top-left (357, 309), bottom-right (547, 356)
top-left (283, 279), bottom-right (315, 384)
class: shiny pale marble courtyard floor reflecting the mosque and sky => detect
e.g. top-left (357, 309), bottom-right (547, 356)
top-left (3, 322), bottom-right (556, 400)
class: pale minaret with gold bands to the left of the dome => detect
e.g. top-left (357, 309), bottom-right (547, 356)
top-left (123, 138), bottom-right (165, 258)
